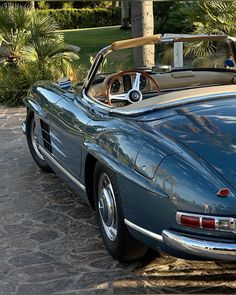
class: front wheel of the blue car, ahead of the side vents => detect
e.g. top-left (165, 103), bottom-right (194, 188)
top-left (26, 110), bottom-right (52, 172)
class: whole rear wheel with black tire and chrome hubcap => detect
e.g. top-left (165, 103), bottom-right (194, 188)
top-left (94, 163), bottom-right (148, 262)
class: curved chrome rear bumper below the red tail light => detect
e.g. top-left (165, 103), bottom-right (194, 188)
top-left (162, 230), bottom-right (236, 261)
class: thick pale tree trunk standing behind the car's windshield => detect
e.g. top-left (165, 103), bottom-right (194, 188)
top-left (131, 0), bottom-right (155, 67)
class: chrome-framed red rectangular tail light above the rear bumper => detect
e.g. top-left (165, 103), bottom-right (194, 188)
top-left (176, 212), bottom-right (236, 232)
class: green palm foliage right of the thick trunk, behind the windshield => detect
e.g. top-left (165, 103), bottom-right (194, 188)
top-left (154, 0), bottom-right (236, 62)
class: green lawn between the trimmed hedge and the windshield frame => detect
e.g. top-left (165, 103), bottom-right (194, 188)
top-left (61, 26), bottom-right (131, 68)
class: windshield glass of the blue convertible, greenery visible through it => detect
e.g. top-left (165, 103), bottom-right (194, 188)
top-left (95, 40), bottom-right (235, 80)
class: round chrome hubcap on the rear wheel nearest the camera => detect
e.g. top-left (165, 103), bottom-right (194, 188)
top-left (98, 173), bottom-right (117, 241)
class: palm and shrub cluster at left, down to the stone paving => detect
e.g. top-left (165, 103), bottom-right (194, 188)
top-left (0, 5), bottom-right (79, 105)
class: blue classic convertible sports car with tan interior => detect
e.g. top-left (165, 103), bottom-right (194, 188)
top-left (22, 35), bottom-right (236, 261)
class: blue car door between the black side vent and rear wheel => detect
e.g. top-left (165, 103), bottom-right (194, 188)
top-left (44, 95), bottom-right (89, 179)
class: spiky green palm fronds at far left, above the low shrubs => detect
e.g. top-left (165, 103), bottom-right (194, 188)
top-left (0, 6), bottom-right (79, 76)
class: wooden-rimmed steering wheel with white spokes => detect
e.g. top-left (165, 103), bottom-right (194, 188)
top-left (107, 70), bottom-right (160, 106)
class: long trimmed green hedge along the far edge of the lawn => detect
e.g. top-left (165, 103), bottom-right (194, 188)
top-left (37, 7), bottom-right (121, 29)
